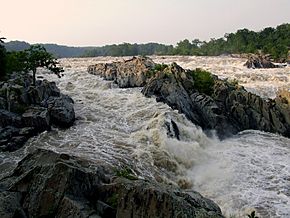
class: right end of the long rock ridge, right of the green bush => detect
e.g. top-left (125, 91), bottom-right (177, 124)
top-left (213, 80), bottom-right (290, 137)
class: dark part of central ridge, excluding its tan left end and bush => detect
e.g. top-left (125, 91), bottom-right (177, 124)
top-left (142, 64), bottom-right (290, 138)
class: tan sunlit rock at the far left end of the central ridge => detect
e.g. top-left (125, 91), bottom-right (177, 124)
top-left (88, 57), bottom-right (155, 88)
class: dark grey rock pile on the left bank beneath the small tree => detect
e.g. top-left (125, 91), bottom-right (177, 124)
top-left (0, 73), bottom-right (75, 151)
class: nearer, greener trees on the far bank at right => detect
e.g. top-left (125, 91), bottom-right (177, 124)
top-left (173, 24), bottom-right (290, 60)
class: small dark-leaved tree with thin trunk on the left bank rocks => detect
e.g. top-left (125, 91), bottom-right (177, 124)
top-left (24, 45), bottom-right (64, 85)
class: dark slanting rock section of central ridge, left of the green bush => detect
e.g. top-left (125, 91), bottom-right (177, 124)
top-left (142, 64), bottom-right (238, 138)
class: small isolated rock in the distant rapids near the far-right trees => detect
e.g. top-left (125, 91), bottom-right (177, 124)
top-left (245, 55), bottom-right (283, 69)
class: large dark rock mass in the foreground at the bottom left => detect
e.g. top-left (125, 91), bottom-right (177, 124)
top-left (0, 150), bottom-right (223, 218)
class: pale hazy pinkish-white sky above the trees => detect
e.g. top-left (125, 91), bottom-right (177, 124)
top-left (0, 0), bottom-right (290, 46)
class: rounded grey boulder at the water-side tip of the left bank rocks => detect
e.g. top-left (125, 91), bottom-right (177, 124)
top-left (46, 95), bottom-right (75, 127)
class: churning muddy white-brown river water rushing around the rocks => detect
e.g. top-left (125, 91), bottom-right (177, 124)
top-left (0, 57), bottom-right (290, 218)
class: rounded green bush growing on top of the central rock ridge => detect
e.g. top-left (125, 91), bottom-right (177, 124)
top-left (190, 68), bottom-right (214, 95)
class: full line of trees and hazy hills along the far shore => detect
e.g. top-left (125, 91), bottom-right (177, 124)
top-left (5, 24), bottom-right (290, 61)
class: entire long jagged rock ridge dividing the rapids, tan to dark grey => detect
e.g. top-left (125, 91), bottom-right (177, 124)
top-left (88, 57), bottom-right (290, 138)
